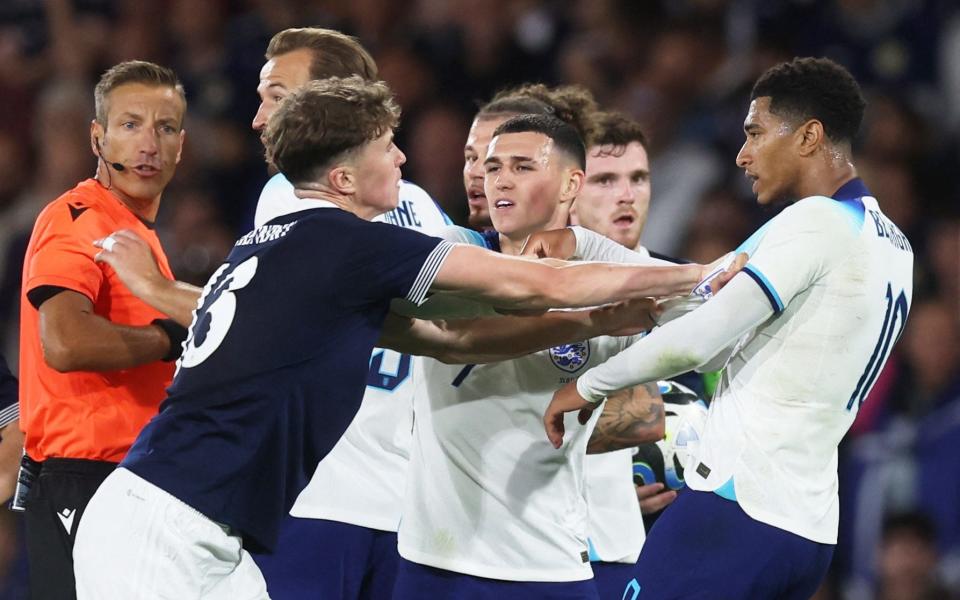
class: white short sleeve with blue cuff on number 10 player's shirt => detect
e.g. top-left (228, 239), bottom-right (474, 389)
top-left (743, 196), bottom-right (863, 313)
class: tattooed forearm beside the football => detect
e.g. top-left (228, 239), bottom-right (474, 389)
top-left (587, 383), bottom-right (664, 454)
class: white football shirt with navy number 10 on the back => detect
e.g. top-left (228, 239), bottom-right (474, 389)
top-left (578, 179), bottom-right (913, 544)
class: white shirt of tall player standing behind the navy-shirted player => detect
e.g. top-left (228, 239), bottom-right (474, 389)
top-left (255, 175), bottom-right (449, 531)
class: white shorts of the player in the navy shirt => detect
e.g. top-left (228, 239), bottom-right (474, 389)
top-left (73, 469), bottom-right (270, 600)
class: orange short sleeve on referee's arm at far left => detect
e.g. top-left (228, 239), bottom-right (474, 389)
top-left (24, 209), bottom-right (105, 302)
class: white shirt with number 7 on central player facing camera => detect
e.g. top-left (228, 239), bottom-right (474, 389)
top-left (398, 226), bottom-right (636, 582)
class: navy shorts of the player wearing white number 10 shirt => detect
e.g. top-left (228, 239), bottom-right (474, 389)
top-left (624, 489), bottom-right (834, 600)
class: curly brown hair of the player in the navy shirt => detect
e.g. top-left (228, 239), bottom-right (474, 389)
top-left (264, 75), bottom-right (400, 185)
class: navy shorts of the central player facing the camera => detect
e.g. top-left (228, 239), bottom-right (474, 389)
top-left (393, 558), bottom-right (599, 600)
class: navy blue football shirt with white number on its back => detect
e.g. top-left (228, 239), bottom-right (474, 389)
top-left (121, 205), bottom-right (452, 551)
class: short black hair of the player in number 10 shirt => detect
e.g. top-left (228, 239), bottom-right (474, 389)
top-left (750, 57), bottom-right (867, 143)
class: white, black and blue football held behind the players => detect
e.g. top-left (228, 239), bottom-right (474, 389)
top-left (633, 381), bottom-right (707, 490)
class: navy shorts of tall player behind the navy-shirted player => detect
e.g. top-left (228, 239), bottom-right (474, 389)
top-left (253, 515), bottom-right (399, 600)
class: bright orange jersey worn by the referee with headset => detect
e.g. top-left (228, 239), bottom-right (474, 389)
top-left (20, 179), bottom-right (174, 462)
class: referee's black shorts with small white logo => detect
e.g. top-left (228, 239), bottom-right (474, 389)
top-left (24, 458), bottom-right (117, 600)
